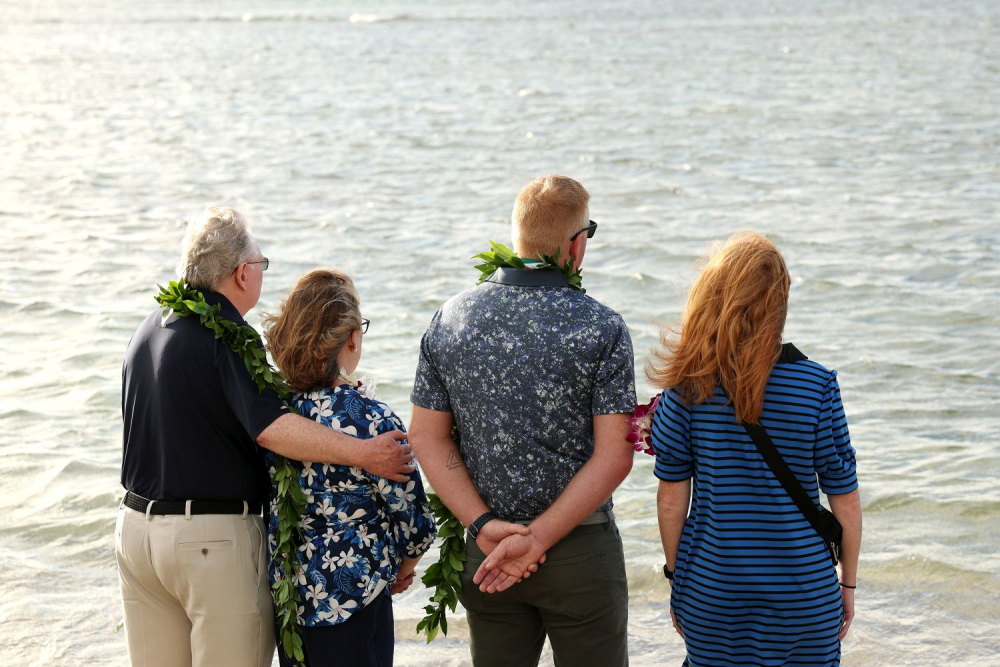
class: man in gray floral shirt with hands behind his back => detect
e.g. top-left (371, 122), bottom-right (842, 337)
top-left (410, 176), bottom-right (635, 667)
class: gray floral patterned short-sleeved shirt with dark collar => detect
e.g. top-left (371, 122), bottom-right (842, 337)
top-left (410, 269), bottom-right (635, 521)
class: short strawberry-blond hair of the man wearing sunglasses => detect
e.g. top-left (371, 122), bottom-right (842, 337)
top-left (511, 175), bottom-right (590, 256)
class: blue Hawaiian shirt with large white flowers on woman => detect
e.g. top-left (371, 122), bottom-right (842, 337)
top-left (267, 384), bottom-right (437, 627)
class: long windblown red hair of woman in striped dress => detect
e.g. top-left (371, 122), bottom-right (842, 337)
top-left (646, 232), bottom-right (790, 424)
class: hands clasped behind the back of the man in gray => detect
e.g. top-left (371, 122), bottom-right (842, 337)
top-left (472, 519), bottom-right (545, 593)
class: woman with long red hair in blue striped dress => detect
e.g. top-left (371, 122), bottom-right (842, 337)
top-left (647, 233), bottom-right (861, 667)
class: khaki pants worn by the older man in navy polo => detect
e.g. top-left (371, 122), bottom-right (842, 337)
top-left (115, 507), bottom-right (274, 667)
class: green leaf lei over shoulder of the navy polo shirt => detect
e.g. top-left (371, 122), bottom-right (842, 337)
top-left (155, 279), bottom-right (306, 667)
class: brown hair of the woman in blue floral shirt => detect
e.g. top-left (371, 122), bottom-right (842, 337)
top-left (263, 269), bottom-right (361, 392)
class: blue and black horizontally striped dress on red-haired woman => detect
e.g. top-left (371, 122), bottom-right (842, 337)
top-left (653, 344), bottom-right (858, 667)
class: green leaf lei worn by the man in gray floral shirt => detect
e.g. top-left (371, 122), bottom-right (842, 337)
top-left (417, 241), bottom-right (587, 643)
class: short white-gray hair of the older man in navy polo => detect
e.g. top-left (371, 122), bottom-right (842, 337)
top-left (179, 206), bottom-right (257, 290)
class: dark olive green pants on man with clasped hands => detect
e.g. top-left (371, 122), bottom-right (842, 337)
top-left (459, 521), bottom-right (628, 667)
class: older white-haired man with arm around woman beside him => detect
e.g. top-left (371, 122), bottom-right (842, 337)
top-left (115, 208), bottom-right (416, 667)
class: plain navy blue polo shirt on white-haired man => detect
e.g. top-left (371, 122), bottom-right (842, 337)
top-left (121, 292), bottom-right (288, 502)
